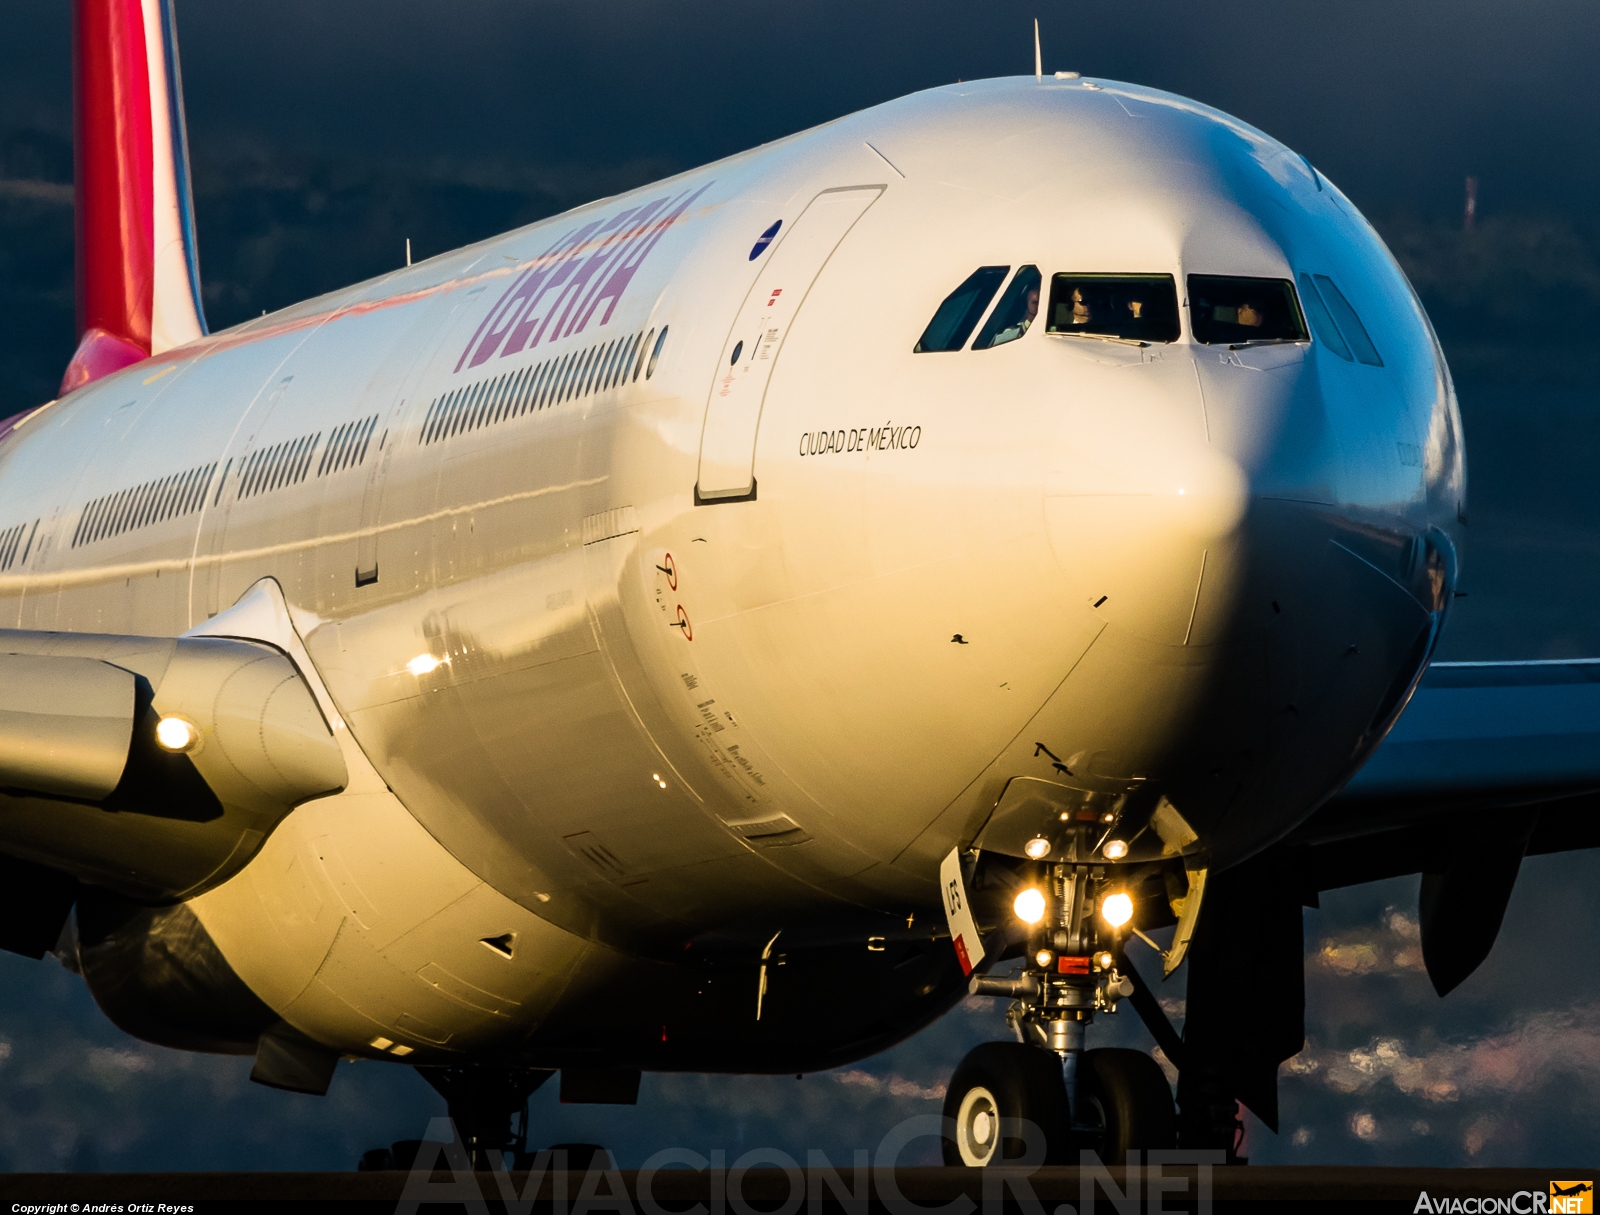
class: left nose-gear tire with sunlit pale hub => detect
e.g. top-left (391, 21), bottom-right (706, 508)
top-left (944, 1042), bottom-right (1068, 1169)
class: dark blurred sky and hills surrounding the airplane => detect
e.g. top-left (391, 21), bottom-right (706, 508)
top-left (0, 0), bottom-right (1600, 1169)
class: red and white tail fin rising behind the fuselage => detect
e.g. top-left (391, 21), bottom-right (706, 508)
top-left (61, 0), bottom-right (206, 395)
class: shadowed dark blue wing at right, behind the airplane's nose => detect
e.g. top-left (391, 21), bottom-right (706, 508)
top-left (1264, 658), bottom-right (1600, 996)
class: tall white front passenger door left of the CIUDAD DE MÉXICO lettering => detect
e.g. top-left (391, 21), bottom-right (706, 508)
top-left (694, 186), bottom-right (883, 503)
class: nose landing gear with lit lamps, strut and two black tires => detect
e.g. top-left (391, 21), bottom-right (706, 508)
top-left (944, 823), bottom-right (1178, 1165)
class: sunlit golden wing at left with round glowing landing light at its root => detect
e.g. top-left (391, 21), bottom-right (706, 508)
top-left (0, 631), bottom-right (349, 903)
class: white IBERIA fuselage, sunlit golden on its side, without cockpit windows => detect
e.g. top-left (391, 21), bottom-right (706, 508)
top-left (0, 78), bottom-right (1464, 1061)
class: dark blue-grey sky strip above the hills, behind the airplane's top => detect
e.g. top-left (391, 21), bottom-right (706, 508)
top-left (9, 0), bottom-right (1600, 220)
